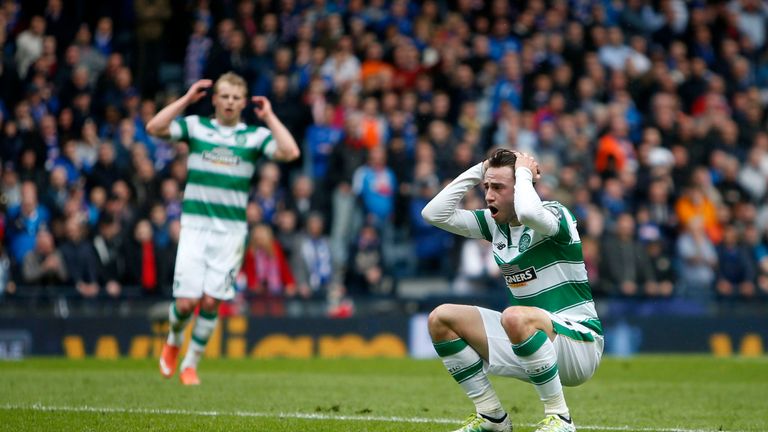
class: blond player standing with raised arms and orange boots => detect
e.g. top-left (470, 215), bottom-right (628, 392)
top-left (147, 72), bottom-right (299, 385)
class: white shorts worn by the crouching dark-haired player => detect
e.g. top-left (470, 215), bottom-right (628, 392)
top-left (477, 307), bottom-right (604, 386)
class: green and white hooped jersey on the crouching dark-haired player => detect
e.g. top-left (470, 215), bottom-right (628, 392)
top-left (468, 201), bottom-right (602, 334)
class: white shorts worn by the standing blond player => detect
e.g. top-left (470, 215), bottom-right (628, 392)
top-left (173, 227), bottom-right (246, 300)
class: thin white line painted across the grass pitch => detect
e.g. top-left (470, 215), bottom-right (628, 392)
top-left (0, 404), bottom-right (746, 432)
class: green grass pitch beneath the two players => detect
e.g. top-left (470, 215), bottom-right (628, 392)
top-left (0, 356), bottom-right (768, 432)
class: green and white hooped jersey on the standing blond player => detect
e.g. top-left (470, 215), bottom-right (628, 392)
top-left (170, 115), bottom-right (276, 232)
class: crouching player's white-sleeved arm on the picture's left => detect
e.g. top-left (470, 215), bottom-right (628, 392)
top-left (421, 163), bottom-right (483, 232)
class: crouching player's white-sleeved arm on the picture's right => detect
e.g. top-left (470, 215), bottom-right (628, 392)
top-left (515, 168), bottom-right (559, 235)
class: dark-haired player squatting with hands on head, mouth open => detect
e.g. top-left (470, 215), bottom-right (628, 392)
top-left (422, 149), bottom-right (603, 432)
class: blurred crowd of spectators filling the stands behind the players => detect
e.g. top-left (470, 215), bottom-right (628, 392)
top-left (0, 0), bottom-right (768, 314)
